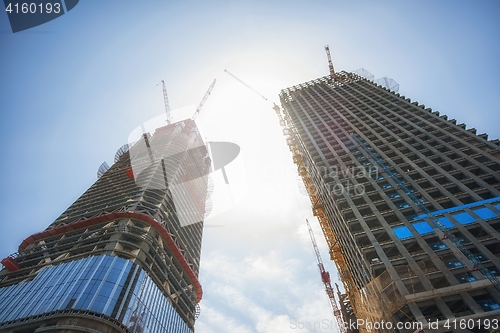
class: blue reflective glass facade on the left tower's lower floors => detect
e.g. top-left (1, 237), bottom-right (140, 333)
top-left (0, 255), bottom-right (192, 333)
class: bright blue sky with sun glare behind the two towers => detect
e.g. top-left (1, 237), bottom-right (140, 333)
top-left (0, 0), bottom-right (500, 333)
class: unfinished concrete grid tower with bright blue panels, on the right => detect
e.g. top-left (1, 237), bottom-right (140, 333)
top-left (275, 67), bottom-right (500, 332)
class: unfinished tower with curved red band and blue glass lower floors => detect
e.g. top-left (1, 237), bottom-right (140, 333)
top-left (0, 120), bottom-right (211, 333)
